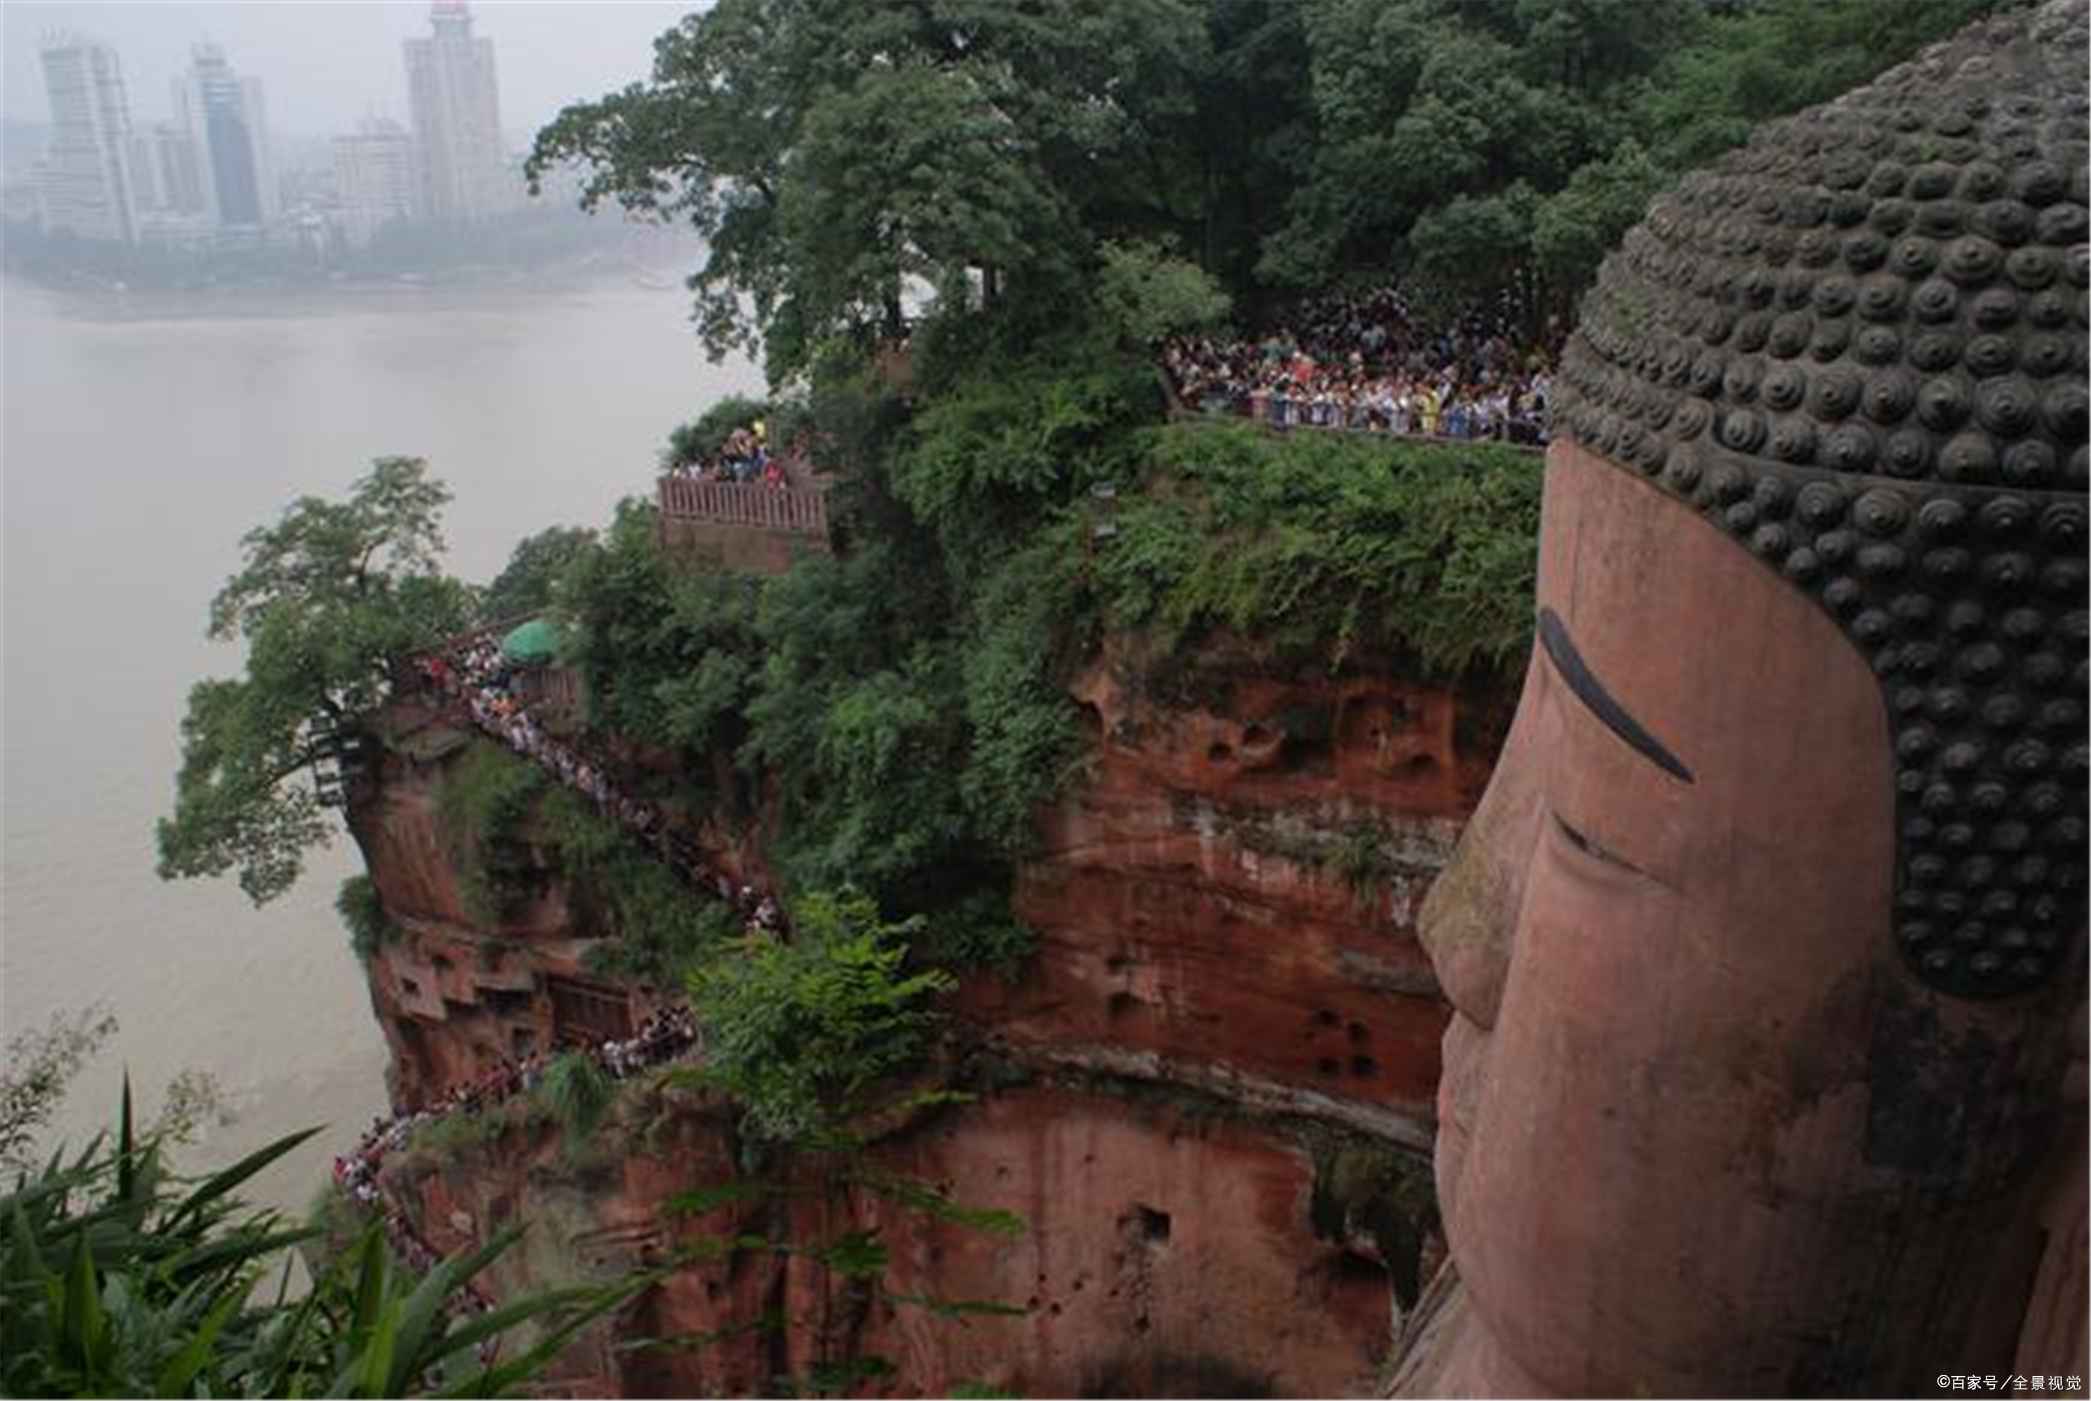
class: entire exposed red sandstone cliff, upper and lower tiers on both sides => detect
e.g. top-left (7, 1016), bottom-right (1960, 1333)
top-left (353, 657), bottom-right (1508, 1395)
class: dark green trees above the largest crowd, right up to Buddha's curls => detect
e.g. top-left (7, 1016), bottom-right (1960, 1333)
top-left (1259, 0), bottom-right (1997, 314)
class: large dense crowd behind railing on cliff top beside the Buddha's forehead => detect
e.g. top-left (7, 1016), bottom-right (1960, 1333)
top-left (1163, 289), bottom-right (1560, 445)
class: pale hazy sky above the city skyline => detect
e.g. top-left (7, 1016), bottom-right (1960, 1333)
top-left (0, 0), bottom-right (703, 138)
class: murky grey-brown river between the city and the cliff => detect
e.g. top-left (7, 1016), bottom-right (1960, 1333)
top-left (0, 274), bottom-right (761, 1207)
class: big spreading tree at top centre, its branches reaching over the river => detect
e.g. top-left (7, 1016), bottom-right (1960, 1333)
top-left (531, 0), bottom-right (1209, 378)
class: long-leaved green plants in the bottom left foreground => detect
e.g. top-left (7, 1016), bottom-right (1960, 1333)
top-left (0, 1089), bottom-right (640, 1397)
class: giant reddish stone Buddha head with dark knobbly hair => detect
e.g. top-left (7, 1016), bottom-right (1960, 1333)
top-left (1424, 0), bottom-right (2087, 1395)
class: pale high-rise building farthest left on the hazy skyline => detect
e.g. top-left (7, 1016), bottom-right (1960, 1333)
top-left (42, 33), bottom-right (138, 243)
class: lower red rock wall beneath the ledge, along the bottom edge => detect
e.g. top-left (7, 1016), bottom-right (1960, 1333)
top-left (387, 1081), bottom-right (1438, 1397)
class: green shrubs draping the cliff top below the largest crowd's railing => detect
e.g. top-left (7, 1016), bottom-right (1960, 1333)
top-left (1089, 422), bottom-right (1541, 677)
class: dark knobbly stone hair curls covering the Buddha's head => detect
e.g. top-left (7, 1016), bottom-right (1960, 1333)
top-left (1556, 4), bottom-right (2091, 1012)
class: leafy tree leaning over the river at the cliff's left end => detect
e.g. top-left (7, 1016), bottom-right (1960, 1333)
top-left (159, 458), bottom-right (473, 903)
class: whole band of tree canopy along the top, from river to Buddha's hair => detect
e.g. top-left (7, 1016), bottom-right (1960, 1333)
top-left (531, 0), bottom-right (1999, 349)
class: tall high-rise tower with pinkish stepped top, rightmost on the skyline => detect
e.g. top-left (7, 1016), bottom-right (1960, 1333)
top-left (406, 0), bottom-right (514, 224)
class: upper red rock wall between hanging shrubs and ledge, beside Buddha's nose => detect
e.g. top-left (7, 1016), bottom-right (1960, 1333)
top-left (964, 657), bottom-right (1508, 1146)
